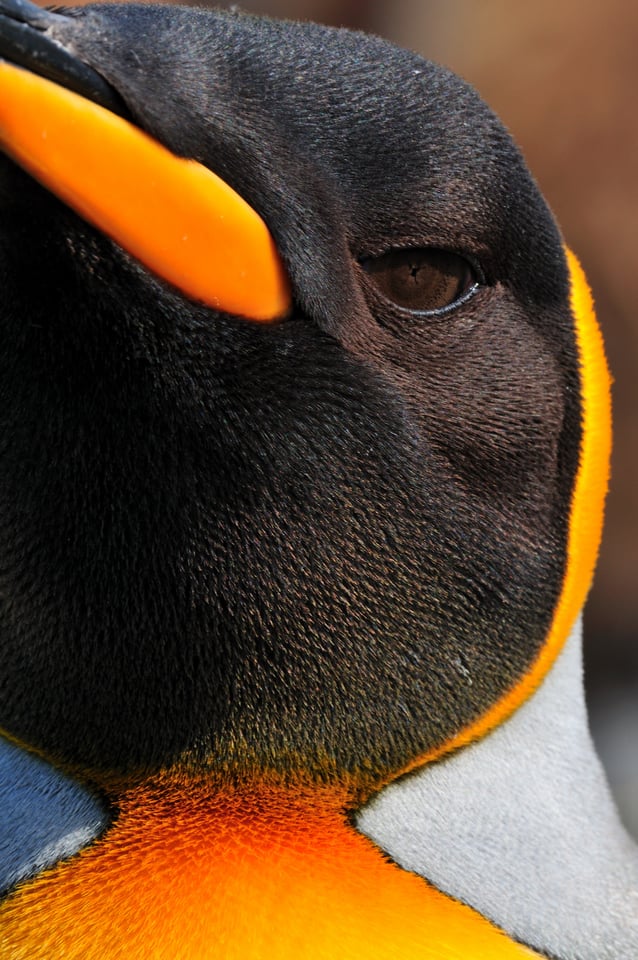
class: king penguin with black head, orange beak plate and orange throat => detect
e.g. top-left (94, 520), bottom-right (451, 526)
top-left (0, 0), bottom-right (638, 960)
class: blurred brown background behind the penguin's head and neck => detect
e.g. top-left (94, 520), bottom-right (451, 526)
top-left (45, 0), bottom-right (638, 835)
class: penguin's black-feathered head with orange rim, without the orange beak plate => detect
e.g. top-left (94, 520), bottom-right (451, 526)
top-left (0, 5), bottom-right (607, 794)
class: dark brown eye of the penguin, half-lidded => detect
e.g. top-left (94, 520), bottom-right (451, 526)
top-left (361, 247), bottom-right (478, 314)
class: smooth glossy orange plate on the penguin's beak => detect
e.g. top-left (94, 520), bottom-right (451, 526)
top-left (0, 61), bottom-right (291, 322)
